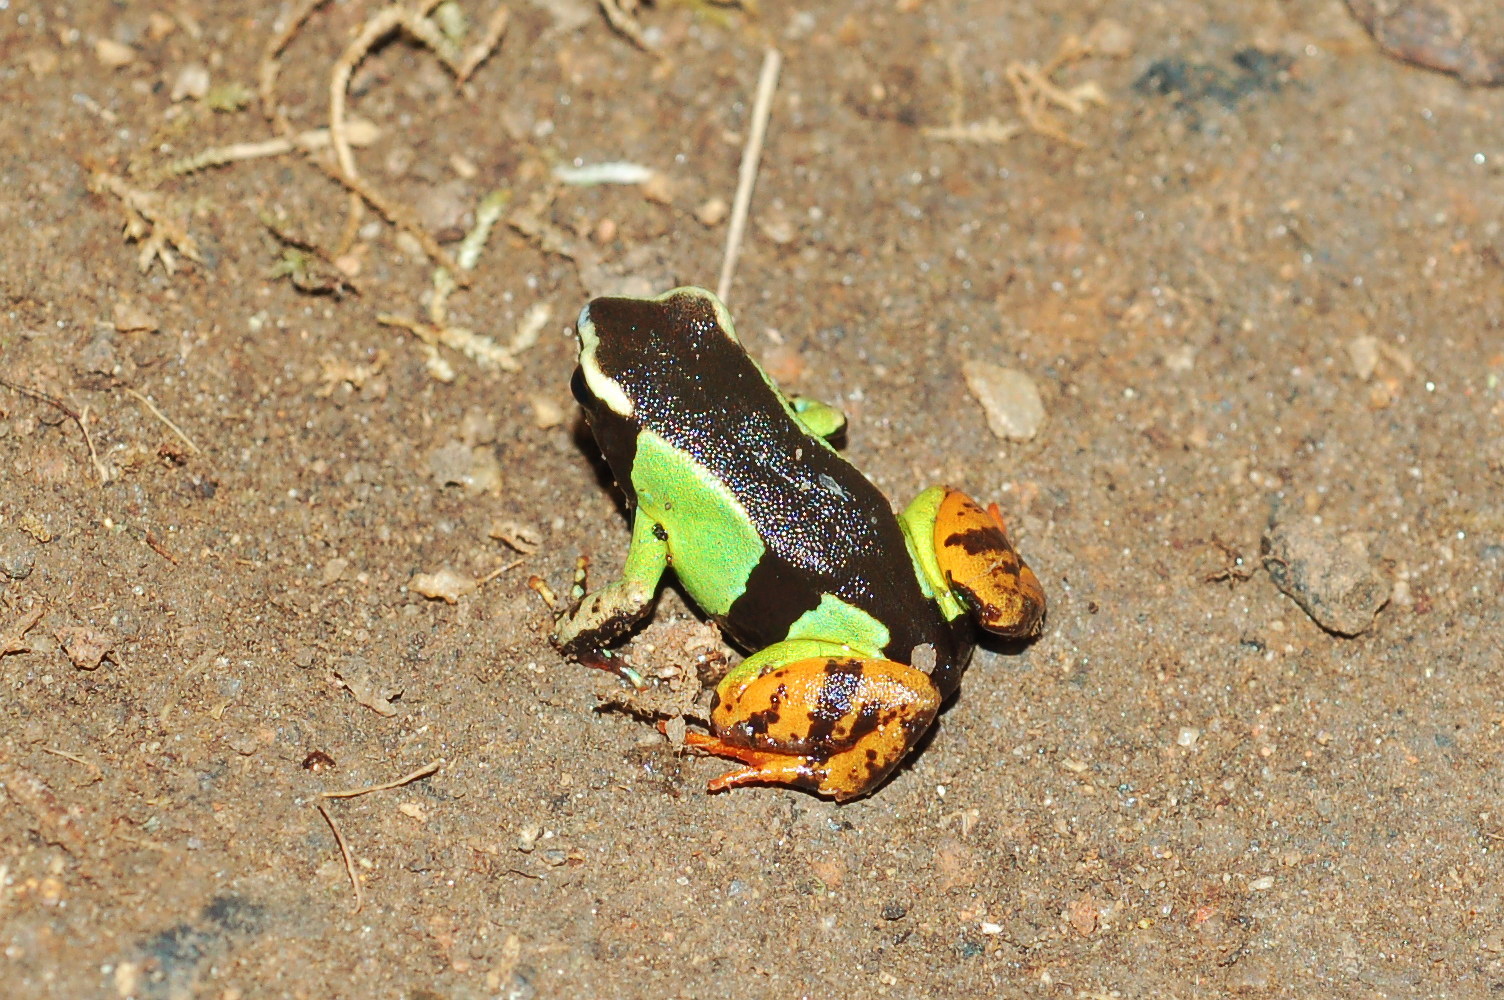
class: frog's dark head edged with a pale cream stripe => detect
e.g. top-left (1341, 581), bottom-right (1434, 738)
top-left (575, 286), bottom-right (744, 418)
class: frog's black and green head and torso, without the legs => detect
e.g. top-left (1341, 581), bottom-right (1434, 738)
top-left (574, 295), bottom-right (955, 666)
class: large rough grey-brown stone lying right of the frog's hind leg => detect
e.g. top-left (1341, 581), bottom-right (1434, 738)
top-left (1263, 520), bottom-right (1390, 636)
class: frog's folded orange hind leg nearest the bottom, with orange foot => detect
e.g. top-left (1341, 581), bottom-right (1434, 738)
top-left (684, 639), bottom-right (942, 802)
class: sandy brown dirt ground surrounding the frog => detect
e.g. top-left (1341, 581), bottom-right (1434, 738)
top-left (0, 0), bottom-right (1504, 1000)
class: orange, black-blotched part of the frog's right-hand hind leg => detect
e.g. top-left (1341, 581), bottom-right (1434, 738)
top-left (934, 490), bottom-right (1044, 636)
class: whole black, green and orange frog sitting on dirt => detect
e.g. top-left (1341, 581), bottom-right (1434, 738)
top-left (550, 286), bottom-right (1045, 802)
